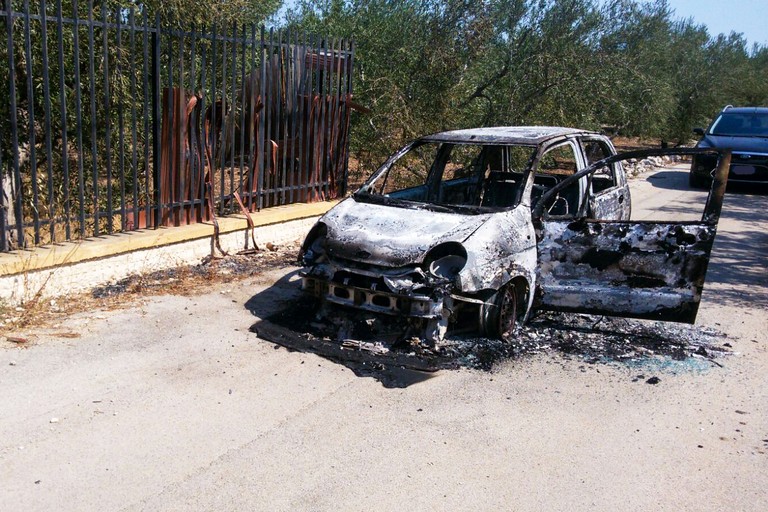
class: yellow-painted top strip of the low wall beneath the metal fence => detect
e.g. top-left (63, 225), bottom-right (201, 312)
top-left (0, 201), bottom-right (338, 276)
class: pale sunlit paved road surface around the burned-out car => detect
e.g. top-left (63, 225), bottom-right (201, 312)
top-left (0, 165), bottom-right (768, 512)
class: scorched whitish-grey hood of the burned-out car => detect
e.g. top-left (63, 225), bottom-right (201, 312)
top-left (321, 198), bottom-right (489, 267)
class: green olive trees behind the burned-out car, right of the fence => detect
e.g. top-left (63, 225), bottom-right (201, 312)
top-left (286, 0), bottom-right (768, 172)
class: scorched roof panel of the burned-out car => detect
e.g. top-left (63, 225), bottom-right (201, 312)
top-left (421, 126), bottom-right (599, 145)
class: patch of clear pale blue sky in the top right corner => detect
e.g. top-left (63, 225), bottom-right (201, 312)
top-left (667, 0), bottom-right (768, 46)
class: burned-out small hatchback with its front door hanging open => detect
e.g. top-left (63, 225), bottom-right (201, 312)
top-left (299, 127), bottom-right (722, 343)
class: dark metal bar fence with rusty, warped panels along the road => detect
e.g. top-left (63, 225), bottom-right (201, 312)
top-left (0, 0), bottom-right (354, 251)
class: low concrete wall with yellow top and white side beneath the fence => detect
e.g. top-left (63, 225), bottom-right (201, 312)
top-left (0, 201), bottom-right (337, 305)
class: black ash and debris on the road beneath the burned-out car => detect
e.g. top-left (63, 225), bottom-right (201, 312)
top-left (251, 300), bottom-right (729, 387)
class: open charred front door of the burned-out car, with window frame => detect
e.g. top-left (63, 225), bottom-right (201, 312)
top-left (533, 149), bottom-right (730, 323)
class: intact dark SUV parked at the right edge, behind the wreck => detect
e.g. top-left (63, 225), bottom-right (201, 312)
top-left (689, 105), bottom-right (768, 188)
